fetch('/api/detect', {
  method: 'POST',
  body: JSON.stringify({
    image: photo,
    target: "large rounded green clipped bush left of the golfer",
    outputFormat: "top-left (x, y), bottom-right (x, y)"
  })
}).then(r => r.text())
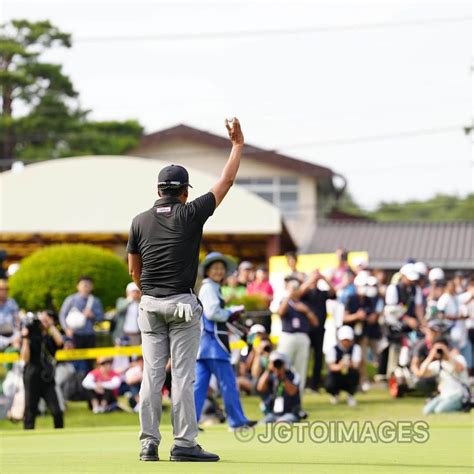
top-left (9, 244), bottom-right (130, 311)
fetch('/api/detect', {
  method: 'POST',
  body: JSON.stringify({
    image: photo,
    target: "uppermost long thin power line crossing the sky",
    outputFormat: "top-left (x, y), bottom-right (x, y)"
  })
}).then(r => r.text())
top-left (75, 16), bottom-right (472, 43)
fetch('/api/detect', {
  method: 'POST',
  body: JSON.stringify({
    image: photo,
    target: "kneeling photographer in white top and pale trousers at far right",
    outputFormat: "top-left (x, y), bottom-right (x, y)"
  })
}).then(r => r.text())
top-left (420, 337), bottom-right (470, 415)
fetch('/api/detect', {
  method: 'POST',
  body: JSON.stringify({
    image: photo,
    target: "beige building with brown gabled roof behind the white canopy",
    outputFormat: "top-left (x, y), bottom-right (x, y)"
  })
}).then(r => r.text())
top-left (130, 124), bottom-right (339, 244)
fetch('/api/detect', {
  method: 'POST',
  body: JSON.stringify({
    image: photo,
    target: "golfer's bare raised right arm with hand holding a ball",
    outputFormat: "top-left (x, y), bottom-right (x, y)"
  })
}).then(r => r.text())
top-left (211, 117), bottom-right (244, 207)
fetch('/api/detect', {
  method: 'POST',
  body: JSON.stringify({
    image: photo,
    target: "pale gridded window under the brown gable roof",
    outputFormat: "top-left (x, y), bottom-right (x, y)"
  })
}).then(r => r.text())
top-left (236, 177), bottom-right (298, 218)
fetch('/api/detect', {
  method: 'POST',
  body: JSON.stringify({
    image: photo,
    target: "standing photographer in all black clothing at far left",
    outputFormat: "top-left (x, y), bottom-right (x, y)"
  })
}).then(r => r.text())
top-left (20, 311), bottom-right (64, 430)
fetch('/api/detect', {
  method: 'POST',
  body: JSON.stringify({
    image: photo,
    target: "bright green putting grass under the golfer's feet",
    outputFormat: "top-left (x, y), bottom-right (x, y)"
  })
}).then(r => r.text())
top-left (0, 390), bottom-right (474, 474)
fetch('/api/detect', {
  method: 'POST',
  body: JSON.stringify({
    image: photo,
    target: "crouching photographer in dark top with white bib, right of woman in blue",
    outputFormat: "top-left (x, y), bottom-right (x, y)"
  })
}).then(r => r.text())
top-left (257, 351), bottom-right (301, 423)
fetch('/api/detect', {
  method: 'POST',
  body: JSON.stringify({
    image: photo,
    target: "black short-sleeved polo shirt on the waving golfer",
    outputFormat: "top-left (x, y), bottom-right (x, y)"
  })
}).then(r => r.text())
top-left (127, 192), bottom-right (216, 297)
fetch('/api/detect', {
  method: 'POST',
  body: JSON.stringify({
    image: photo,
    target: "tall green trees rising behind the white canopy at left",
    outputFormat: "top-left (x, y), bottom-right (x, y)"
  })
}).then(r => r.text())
top-left (0, 20), bottom-right (143, 164)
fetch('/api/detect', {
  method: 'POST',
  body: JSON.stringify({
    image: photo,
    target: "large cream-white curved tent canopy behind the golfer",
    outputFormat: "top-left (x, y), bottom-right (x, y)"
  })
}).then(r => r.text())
top-left (0, 156), bottom-right (282, 235)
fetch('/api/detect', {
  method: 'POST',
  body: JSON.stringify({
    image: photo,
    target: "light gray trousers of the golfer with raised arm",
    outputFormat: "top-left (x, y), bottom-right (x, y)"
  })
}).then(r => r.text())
top-left (138, 293), bottom-right (202, 447)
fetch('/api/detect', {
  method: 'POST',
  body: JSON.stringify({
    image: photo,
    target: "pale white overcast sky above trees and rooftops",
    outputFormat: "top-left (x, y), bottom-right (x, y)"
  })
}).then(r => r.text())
top-left (0, 0), bottom-right (473, 207)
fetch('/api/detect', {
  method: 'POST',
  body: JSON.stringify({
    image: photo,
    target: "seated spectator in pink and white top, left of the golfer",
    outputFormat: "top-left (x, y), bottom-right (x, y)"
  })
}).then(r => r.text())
top-left (82, 357), bottom-right (122, 414)
